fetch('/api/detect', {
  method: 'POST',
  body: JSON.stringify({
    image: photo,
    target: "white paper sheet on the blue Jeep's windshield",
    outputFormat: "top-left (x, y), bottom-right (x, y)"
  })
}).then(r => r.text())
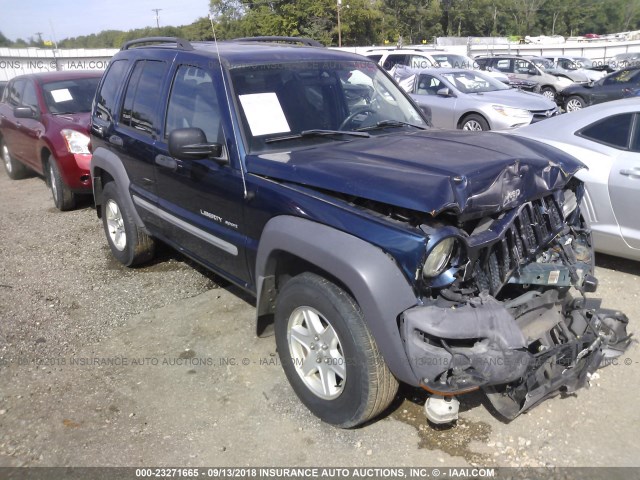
top-left (240, 92), bottom-right (291, 137)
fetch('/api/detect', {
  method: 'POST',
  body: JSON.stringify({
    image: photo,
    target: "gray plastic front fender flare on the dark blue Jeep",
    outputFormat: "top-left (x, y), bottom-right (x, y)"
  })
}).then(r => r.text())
top-left (256, 216), bottom-right (419, 385)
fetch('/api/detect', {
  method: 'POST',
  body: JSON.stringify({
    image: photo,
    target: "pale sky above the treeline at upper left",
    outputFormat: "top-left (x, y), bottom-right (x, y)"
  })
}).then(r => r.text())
top-left (0, 0), bottom-right (209, 40)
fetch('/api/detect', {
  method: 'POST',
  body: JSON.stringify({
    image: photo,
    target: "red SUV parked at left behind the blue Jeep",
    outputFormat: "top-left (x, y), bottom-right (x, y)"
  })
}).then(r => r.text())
top-left (0, 71), bottom-right (102, 210)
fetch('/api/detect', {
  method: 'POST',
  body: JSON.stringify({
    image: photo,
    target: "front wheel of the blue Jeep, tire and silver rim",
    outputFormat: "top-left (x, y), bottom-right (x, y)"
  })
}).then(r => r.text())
top-left (275, 273), bottom-right (398, 428)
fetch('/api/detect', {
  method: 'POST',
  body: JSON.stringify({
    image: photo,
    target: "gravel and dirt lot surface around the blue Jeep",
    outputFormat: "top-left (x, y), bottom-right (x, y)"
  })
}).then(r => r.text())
top-left (0, 174), bottom-right (640, 466)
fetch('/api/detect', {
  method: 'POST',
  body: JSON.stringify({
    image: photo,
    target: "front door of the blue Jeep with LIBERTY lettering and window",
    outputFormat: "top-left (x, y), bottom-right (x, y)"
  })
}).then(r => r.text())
top-left (154, 61), bottom-right (249, 284)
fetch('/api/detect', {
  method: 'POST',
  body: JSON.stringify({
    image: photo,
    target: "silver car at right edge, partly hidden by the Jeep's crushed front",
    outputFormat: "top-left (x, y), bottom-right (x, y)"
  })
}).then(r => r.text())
top-left (510, 98), bottom-right (640, 260)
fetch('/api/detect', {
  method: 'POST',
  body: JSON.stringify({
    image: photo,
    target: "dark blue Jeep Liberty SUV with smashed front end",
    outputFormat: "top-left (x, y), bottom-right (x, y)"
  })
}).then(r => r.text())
top-left (91, 38), bottom-right (628, 427)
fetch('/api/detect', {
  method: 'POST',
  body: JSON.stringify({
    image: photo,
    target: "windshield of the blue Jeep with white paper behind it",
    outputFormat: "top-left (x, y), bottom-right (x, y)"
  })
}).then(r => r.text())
top-left (231, 60), bottom-right (427, 153)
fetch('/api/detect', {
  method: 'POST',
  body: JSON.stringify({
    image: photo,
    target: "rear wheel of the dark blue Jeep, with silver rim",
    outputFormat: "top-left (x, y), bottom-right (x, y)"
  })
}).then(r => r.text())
top-left (101, 182), bottom-right (155, 267)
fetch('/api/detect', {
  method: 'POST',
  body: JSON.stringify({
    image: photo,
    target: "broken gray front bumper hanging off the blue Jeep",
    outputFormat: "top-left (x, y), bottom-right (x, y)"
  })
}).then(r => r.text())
top-left (401, 290), bottom-right (629, 419)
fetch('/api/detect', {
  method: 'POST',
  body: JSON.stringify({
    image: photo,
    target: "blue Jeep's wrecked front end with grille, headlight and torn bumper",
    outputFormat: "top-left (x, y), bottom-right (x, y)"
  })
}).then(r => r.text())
top-left (400, 179), bottom-right (630, 419)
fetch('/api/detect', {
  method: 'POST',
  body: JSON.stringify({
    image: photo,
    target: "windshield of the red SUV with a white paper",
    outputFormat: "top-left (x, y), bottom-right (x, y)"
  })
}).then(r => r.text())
top-left (42, 77), bottom-right (100, 114)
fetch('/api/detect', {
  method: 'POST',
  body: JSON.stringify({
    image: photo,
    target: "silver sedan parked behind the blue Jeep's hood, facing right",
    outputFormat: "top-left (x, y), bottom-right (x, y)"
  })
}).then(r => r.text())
top-left (392, 67), bottom-right (558, 130)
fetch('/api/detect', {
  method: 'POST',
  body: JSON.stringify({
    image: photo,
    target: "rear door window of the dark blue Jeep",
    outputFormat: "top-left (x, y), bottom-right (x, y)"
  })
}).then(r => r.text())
top-left (120, 60), bottom-right (167, 135)
